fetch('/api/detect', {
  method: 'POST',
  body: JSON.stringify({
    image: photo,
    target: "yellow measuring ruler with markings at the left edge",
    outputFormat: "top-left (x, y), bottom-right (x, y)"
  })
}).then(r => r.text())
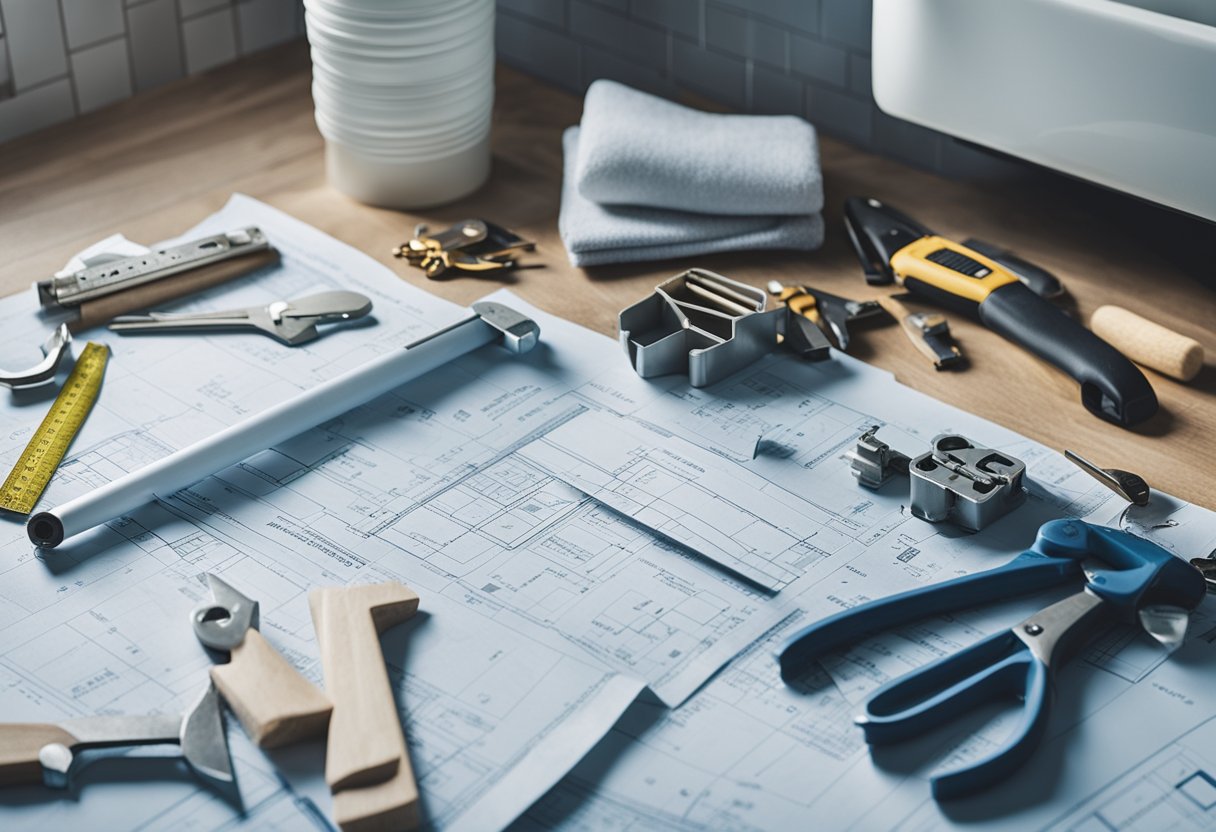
top-left (0, 342), bottom-right (109, 515)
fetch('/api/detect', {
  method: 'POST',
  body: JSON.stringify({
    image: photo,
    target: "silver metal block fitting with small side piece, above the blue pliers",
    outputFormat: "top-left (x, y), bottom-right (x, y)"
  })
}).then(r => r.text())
top-left (845, 426), bottom-right (1026, 532)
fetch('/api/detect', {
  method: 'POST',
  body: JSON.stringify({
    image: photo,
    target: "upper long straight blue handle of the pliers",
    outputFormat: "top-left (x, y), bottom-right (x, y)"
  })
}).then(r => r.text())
top-left (776, 551), bottom-right (1081, 679)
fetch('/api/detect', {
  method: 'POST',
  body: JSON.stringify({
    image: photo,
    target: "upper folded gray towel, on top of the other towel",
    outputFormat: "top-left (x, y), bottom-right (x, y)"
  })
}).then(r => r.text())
top-left (574, 80), bottom-right (823, 215)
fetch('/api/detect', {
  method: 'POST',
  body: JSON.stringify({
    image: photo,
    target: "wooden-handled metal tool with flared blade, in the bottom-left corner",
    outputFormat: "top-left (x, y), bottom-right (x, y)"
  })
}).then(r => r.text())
top-left (0, 684), bottom-right (236, 793)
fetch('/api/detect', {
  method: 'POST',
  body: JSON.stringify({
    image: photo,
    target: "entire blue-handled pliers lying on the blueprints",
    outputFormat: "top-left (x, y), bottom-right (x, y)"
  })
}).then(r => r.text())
top-left (777, 519), bottom-right (1206, 800)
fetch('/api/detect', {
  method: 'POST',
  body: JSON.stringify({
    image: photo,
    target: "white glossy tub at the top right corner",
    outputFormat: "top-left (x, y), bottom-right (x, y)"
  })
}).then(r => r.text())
top-left (873, 0), bottom-right (1216, 221)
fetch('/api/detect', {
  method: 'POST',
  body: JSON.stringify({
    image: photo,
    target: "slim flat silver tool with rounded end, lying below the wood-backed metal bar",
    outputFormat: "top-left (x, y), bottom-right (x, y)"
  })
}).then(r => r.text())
top-left (109, 292), bottom-right (372, 347)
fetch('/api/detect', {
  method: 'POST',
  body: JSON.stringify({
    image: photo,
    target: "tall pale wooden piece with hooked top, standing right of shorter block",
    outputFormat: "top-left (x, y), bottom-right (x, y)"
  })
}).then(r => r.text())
top-left (309, 581), bottom-right (418, 832)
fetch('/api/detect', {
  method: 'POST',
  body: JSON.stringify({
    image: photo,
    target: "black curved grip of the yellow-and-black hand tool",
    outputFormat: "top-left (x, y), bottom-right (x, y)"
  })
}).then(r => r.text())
top-left (979, 283), bottom-right (1158, 426)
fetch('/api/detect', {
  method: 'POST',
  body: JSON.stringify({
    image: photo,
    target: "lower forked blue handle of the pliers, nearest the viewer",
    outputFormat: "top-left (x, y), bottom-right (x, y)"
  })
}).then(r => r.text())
top-left (857, 630), bottom-right (1051, 800)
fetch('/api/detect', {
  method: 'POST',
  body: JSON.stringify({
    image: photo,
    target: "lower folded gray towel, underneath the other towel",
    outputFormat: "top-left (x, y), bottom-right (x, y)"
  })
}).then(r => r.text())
top-left (557, 127), bottom-right (823, 266)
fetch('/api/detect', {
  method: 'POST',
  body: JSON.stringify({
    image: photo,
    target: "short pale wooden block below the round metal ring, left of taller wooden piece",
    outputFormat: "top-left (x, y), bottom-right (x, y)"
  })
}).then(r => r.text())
top-left (212, 630), bottom-right (332, 748)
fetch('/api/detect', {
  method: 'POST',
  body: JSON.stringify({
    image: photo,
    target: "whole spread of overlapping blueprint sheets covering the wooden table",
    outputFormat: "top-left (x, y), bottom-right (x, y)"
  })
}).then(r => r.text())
top-left (0, 197), bottom-right (1216, 830)
